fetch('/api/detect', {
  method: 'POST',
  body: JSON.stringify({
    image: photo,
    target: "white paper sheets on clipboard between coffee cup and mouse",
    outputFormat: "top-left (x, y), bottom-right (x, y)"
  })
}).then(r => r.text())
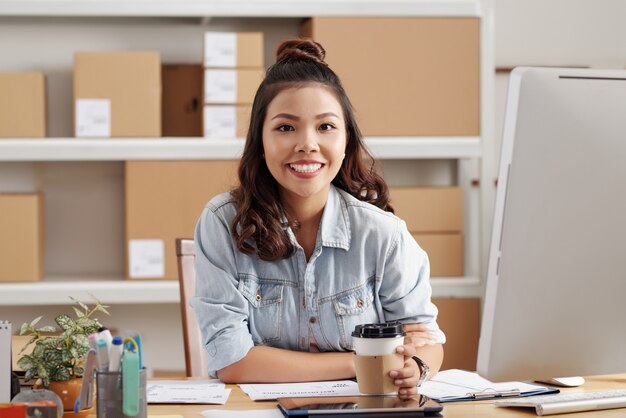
top-left (419, 369), bottom-right (541, 399)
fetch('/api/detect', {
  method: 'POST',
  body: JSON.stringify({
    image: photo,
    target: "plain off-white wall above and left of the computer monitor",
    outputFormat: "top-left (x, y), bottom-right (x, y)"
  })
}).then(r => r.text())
top-left (494, 0), bottom-right (626, 168)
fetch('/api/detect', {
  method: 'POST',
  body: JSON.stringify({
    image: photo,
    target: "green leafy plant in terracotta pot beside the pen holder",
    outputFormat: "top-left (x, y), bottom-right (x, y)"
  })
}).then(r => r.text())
top-left (17, 296), bottom-right (109, 410)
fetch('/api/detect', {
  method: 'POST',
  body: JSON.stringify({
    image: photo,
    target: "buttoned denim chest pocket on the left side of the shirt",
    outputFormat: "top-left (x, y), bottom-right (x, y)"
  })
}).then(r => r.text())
top-left (239, 276), bottom-right (285, 344)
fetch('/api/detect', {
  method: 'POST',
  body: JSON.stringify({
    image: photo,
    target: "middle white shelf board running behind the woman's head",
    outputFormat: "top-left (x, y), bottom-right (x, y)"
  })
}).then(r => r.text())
top-left (0, 137), bottom-right (481, 161)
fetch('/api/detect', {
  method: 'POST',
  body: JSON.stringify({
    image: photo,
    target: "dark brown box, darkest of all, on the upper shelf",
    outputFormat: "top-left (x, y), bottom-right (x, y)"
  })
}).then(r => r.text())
top-left (161, 64), bottom-right (204, 137)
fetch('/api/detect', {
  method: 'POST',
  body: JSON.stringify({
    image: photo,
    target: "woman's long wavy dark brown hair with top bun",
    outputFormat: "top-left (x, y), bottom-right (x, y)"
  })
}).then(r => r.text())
top-left (232, 39), bottom-right (393, 261)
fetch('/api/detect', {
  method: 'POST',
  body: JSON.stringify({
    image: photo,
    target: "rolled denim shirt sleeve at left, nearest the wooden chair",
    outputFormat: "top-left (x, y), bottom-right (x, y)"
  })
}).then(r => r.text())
top-left (191, 204), bottom-right (254, 377)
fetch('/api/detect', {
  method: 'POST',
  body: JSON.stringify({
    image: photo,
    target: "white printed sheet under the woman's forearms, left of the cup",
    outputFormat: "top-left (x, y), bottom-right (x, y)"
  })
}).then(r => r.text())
top-left (239, 380), bottom-right (360, 401)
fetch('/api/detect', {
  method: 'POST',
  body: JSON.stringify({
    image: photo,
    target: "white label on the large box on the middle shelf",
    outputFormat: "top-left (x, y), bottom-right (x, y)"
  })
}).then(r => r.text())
top-left (128, 239), bottom-right (165, 279)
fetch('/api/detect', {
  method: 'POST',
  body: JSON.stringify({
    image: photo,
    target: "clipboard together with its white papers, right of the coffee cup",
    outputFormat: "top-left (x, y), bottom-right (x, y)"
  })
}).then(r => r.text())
top-left (419, 369), bottom-right (559, 402)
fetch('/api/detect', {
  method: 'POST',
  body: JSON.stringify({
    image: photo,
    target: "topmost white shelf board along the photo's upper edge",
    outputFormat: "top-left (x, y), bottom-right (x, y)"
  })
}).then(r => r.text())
top-left (0, 0), bottom-right (483, 17)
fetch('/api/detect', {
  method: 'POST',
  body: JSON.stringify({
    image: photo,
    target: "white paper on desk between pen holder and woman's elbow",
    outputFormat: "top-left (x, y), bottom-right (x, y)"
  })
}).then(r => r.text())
top-left (146, 380), bottom-right (230, 405)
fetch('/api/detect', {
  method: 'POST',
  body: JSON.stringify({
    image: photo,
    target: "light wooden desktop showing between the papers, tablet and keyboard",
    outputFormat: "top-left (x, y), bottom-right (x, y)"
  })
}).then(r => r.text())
top-left (148, 374), bottom-right (626, 418)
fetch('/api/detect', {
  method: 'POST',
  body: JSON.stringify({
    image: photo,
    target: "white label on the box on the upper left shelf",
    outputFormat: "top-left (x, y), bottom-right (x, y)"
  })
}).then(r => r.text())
top-left (75, 99), bottom-right (111, 138)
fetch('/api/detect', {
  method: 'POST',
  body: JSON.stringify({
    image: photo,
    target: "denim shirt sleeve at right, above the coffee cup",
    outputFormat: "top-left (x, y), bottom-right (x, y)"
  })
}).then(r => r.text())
top-left (379, 220), bottom-right (446, 344)
